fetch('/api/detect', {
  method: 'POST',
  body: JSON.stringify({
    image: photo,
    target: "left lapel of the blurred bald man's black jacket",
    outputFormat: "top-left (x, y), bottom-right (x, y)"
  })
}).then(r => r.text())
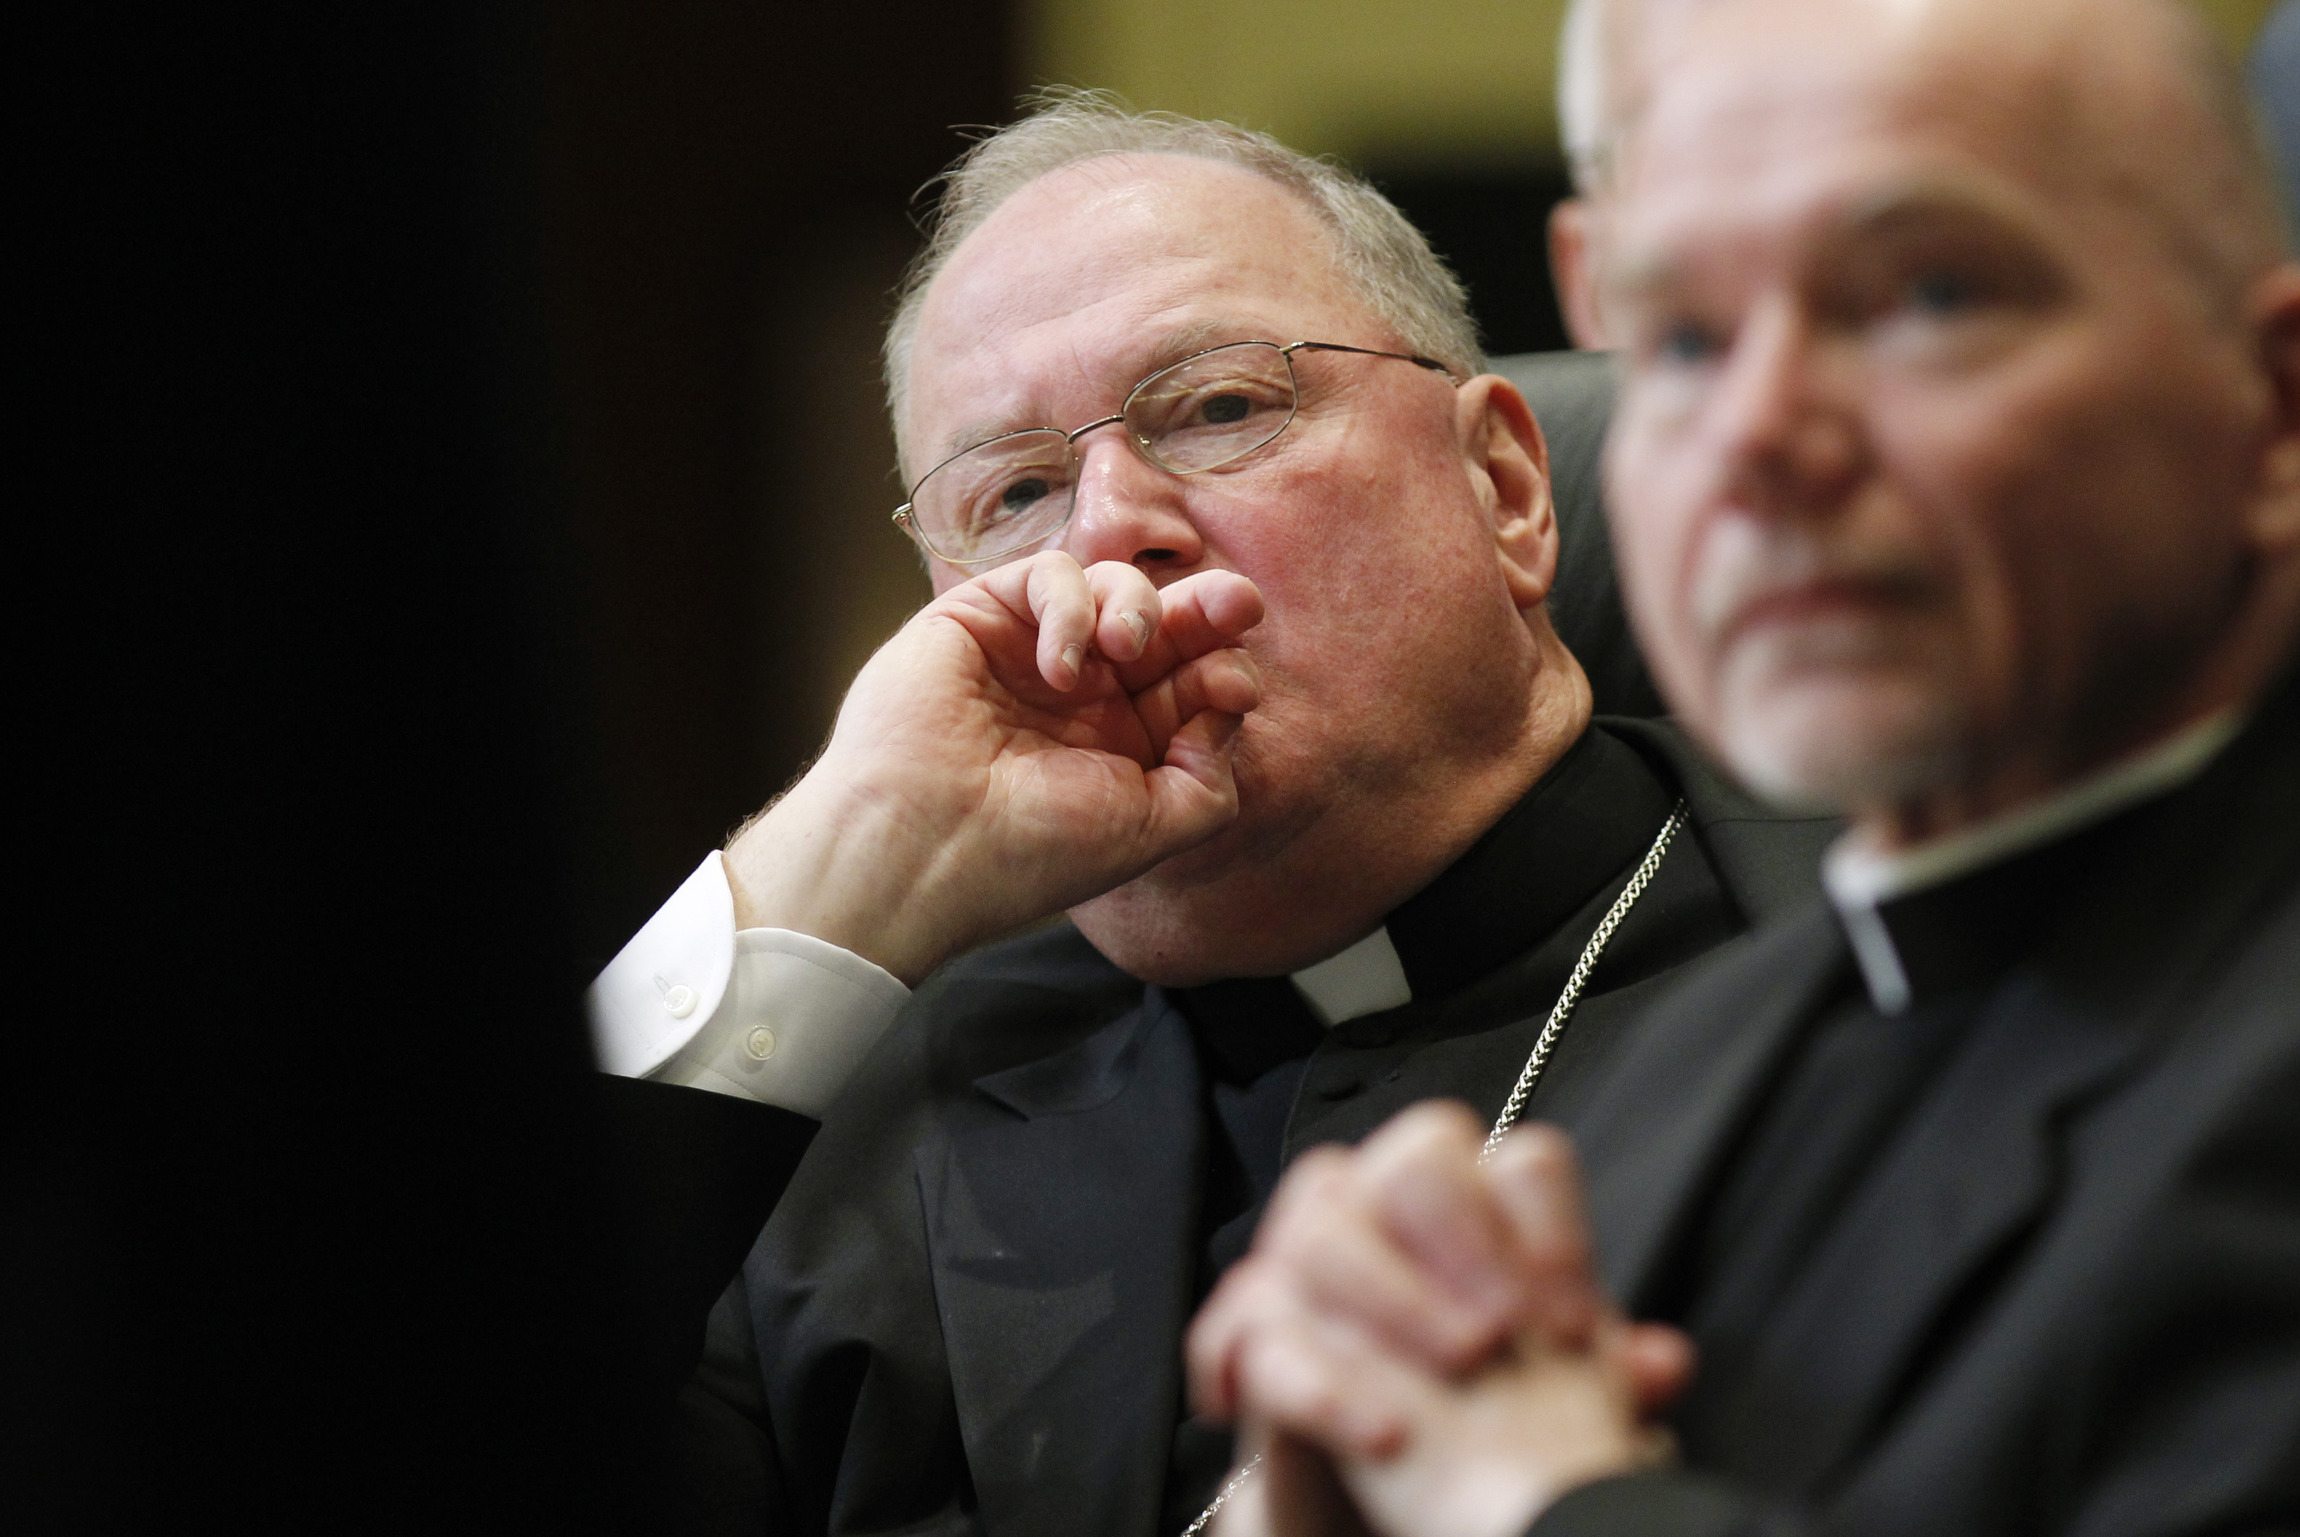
top-left (1566, 902), bottom-right (1849, 1314)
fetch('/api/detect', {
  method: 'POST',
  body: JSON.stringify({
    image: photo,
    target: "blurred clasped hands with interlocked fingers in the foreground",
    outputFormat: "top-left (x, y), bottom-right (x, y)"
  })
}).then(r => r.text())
top-left (1189, 1104), bottom-right (1693, 1537)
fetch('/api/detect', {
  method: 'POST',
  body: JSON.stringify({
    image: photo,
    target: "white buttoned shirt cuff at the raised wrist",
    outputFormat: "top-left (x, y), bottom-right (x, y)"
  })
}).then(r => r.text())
top-left (591, 851), bottom-right (911, 1118)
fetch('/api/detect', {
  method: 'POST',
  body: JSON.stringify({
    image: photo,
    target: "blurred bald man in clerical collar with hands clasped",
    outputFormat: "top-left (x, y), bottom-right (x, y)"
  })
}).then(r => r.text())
top-left (1191, 0), bottom-right (2300, 1537)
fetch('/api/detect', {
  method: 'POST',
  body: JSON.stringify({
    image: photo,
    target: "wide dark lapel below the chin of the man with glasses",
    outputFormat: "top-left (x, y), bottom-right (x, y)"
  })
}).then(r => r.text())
top-left (915, 1003), bottom-right (1203, 1537)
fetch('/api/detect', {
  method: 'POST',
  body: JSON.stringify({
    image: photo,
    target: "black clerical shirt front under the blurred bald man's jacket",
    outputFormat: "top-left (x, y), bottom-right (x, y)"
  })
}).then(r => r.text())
top-left (1661, 808), bottom-right (2180, 1498)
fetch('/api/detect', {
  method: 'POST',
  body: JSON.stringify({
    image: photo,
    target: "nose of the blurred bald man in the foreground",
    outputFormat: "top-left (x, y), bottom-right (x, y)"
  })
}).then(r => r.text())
top-left (1714, 301), bottom-right (1868, 518)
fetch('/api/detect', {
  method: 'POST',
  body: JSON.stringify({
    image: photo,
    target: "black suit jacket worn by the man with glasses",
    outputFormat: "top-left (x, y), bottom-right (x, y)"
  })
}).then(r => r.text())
top-left (690, 720), bottom-right (1833, 1537)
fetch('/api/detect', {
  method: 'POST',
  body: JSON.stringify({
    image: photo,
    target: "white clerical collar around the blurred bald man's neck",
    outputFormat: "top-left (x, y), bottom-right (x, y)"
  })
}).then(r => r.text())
top-left (1822, 709), bottom-right (2245, 1015)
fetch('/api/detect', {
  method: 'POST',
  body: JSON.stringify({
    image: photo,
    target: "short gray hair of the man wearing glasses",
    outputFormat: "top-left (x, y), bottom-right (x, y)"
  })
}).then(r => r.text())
top-left (886, 87), bottom-right (1486, 462)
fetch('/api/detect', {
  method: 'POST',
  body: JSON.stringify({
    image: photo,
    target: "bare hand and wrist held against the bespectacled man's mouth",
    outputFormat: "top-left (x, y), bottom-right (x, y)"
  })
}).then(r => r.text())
top-left (727, 552), bottom-right (1263, 982)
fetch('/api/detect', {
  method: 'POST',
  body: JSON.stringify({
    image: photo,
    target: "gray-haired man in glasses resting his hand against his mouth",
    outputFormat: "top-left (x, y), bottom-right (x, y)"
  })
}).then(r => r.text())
top-left (593, 99), bottom-right (1829, 1537)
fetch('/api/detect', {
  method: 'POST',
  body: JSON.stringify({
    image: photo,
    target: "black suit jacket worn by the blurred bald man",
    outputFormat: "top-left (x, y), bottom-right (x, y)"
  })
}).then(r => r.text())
top-left (1534, 683), bottom-right (2300, 1537)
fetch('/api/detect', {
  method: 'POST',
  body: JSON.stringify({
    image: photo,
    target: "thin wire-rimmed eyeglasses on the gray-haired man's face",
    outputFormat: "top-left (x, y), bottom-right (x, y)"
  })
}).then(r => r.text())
top-left (895, 341), bottom-right (1454, 566)
